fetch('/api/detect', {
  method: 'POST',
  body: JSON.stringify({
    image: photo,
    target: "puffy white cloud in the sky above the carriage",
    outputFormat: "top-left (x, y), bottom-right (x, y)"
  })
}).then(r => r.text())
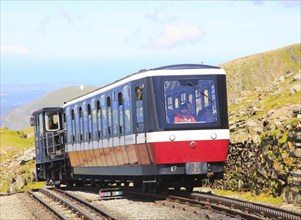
top-left (151, 22), bottom-right (203, 48)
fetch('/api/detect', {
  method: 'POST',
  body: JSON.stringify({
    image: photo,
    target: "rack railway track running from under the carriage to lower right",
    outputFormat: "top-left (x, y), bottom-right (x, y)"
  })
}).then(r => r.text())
top-left (122, 191), bottom-right (301, 220)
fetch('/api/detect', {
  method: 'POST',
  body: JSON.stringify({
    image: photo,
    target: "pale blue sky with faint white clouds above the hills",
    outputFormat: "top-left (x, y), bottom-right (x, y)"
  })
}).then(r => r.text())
top-left (1, 0), bottom-right (301, 86)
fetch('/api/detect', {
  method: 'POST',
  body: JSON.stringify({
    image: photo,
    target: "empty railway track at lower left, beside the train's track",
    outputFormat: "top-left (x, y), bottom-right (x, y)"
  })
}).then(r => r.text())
top-left (29, 188), bottom-right (114, 220)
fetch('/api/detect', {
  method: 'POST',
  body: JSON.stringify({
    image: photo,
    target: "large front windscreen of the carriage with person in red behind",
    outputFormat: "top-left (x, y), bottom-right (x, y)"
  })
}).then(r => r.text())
top-left (164, 79), bottom-right (218, 124)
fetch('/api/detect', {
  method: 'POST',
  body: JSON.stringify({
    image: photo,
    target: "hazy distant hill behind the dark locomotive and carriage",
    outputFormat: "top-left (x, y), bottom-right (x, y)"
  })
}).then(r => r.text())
top-left (2, 86), bottom-right (97, 130)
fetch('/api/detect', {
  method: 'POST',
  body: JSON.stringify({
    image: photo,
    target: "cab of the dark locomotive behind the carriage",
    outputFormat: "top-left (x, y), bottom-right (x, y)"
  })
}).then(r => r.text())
top-left (30, 107), bottom-right (65, 163)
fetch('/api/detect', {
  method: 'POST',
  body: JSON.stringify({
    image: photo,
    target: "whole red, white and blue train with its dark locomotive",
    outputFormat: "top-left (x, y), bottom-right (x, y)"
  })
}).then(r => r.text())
top-left (31, 64), bottom-right (229, 191)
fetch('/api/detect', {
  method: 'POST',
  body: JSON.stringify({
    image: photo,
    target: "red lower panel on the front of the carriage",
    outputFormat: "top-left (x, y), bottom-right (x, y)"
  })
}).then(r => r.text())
top-left (149, 140), bottom-right (229, 164)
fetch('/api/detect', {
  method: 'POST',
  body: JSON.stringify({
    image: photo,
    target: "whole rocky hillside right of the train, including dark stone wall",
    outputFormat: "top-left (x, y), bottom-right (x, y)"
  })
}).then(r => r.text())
top-left (209, 44), bottom-right (301, 206)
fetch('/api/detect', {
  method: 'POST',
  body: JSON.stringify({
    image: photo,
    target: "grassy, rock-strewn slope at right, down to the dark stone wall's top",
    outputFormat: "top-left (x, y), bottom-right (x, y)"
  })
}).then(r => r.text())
top-left (221, 44), bottom-right (301, 142)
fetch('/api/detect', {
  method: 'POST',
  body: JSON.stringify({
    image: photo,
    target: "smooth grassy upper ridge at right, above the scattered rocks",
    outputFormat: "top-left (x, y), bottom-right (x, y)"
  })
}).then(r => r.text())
top-left (220, 44), bottom-right (301, 104)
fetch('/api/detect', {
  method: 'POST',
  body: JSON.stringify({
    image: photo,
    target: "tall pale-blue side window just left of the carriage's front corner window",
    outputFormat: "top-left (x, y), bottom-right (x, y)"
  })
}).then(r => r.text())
top-left (123, 86), bottom-right (132, 134)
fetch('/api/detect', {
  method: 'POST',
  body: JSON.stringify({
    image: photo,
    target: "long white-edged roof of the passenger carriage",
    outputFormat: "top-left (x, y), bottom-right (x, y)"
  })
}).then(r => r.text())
top-left (64, 64), bottom-right (225, 107)
